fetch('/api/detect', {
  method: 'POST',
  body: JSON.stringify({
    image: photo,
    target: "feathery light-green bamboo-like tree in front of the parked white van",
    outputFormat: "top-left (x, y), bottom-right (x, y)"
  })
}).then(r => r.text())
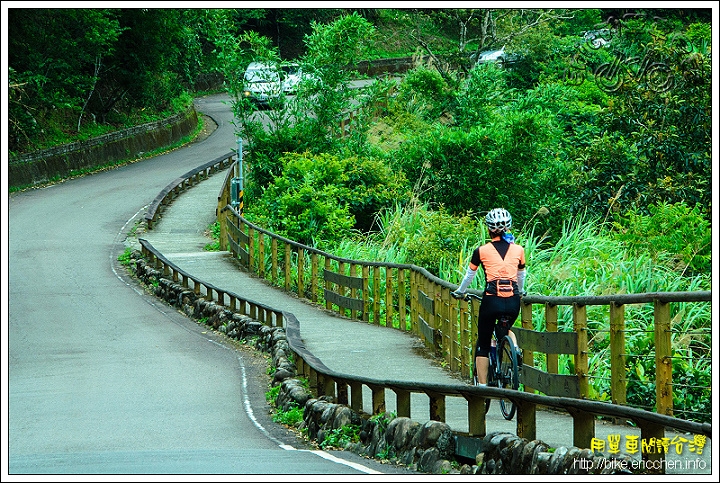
top-left (226, 14), bottom-right (374, 197)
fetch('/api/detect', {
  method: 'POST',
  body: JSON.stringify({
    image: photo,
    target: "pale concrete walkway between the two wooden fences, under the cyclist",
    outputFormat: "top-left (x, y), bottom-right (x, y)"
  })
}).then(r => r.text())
top-left (127, 167), bottom-right (710, 473)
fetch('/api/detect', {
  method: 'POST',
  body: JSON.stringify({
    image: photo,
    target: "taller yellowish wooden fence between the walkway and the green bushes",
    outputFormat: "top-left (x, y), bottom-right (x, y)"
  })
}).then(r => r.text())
top-left (217, 161), bottom-right (711, 422)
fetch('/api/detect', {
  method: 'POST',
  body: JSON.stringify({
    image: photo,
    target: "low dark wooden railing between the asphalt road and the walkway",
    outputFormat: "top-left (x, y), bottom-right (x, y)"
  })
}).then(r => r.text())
top-left (134, 239), bottom-right (712, 464)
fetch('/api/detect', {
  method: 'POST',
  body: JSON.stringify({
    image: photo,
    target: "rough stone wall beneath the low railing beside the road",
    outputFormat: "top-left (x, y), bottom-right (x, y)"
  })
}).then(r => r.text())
top-left (130, 250), bottom-right (632, 475)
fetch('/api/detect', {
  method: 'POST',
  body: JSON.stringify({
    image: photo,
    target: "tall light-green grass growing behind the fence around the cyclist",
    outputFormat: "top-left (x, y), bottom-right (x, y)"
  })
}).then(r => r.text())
top-left (332, 205), bottom-right (711, 421)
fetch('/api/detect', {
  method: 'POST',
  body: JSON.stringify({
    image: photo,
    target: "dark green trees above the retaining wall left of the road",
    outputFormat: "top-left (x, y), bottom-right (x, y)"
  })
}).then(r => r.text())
top-left (7, 8), bottom-right (343, 153)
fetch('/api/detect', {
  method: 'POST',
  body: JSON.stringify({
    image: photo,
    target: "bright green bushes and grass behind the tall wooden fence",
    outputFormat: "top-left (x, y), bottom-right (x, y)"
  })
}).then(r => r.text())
top-left (218, 8), bottom-right (711, 420)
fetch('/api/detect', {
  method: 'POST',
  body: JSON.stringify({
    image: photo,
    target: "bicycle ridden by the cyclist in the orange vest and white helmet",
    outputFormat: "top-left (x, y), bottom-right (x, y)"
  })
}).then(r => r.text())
top-left (462, 293), bottom-right (520, 421)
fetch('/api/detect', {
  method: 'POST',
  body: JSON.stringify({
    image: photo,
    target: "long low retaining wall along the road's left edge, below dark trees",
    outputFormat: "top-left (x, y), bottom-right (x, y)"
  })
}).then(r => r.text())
top-left (8, 107), bottom-right (198, 188)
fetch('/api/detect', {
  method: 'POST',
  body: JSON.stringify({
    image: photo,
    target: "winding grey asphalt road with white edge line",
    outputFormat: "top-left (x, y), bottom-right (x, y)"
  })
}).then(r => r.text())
top-left (2, 95), bottom-right (416, 481)
